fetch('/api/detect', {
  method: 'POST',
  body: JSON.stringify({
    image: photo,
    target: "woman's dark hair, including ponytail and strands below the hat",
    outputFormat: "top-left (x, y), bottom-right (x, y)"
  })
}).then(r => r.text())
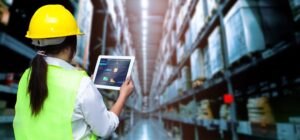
top-left (28, 36), bottom-right (77, 116)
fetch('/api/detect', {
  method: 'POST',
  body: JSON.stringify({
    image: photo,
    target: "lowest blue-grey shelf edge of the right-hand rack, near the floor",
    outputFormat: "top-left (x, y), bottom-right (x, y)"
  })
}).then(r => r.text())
top-left (161, 115), bottom-right (296, 139)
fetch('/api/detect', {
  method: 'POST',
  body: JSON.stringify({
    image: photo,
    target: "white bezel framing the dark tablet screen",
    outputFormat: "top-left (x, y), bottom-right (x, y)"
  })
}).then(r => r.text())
top-left (93, 55), bottom-right (135, 90)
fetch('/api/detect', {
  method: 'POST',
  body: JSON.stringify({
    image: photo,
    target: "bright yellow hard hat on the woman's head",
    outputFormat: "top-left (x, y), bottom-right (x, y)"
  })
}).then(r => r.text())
top-left (26, 5), bottom-right (83, 39)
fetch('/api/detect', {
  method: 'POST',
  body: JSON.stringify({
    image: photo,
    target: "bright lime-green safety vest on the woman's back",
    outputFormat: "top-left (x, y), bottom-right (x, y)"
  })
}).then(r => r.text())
top-left (13, 65), bottom-right (96, 140)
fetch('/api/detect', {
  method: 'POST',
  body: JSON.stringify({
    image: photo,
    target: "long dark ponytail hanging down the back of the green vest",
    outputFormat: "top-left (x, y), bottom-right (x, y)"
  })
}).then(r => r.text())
top-left (28, 54), bottom-right (48, 116)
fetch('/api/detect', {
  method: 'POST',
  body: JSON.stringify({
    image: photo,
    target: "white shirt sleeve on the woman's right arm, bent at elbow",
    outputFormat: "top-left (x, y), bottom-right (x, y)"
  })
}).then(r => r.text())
top-left (78, 77), bottom-right (119, 137)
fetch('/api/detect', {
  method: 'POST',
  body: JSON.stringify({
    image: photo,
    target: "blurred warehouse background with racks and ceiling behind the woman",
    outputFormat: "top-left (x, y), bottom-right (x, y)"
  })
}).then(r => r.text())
top-left (0, 0), bottom-right (300, 140)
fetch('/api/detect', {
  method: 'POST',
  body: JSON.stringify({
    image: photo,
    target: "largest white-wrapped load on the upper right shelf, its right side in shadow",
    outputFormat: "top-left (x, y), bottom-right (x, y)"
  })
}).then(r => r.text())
top-left (225, 0), bottom-right (291, 64)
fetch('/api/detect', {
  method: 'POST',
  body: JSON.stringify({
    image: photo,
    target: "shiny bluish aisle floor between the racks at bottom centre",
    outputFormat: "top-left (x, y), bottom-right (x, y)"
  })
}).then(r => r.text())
top-left (121, 119), bottom-right (171, 140)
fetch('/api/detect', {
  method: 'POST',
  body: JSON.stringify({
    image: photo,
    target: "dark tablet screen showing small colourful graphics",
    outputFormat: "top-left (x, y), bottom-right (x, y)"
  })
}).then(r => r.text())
top-left (94, 58), bottom-right (131, 87)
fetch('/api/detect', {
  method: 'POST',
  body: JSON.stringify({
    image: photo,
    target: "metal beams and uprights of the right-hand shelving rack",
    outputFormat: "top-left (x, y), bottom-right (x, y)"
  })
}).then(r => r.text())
top-left (151, 0), bottom-right (300, 140)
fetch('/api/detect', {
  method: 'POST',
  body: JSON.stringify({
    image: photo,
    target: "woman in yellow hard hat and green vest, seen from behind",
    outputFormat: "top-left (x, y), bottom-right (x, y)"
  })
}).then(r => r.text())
top-left (13, 5), bottom-right (133, 140)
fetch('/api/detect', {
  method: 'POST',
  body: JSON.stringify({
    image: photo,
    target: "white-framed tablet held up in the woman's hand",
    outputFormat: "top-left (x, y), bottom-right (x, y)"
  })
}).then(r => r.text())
top-left (93, 55), bottom-right (135, 90)
